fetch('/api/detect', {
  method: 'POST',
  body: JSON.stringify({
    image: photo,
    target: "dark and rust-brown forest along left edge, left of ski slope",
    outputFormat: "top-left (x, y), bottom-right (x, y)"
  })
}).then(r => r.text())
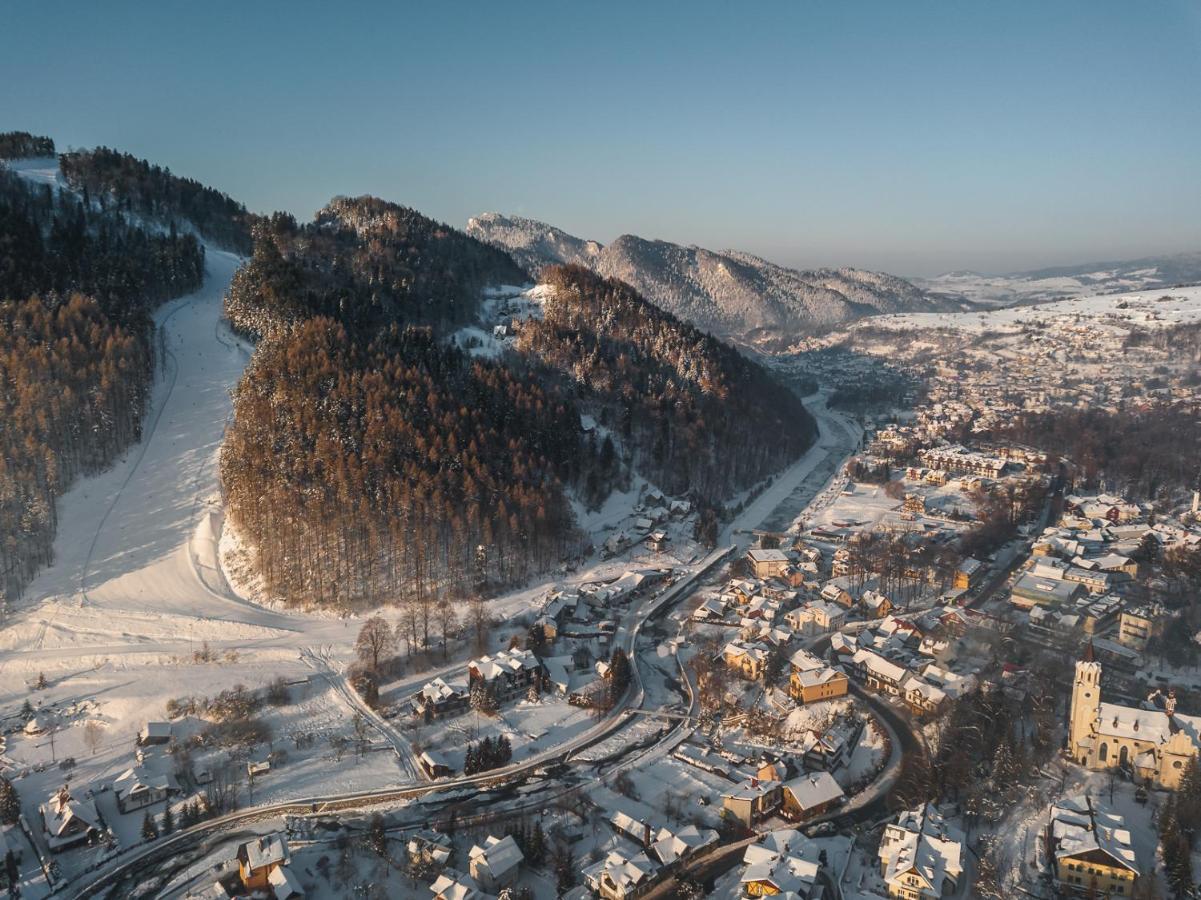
top-left (0, 133), bottom-right (204, 597)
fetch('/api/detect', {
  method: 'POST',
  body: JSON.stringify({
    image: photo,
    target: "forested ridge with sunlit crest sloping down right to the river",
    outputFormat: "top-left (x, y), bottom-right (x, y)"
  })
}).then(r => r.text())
top-left (518, 266), bottom-right (817, 501)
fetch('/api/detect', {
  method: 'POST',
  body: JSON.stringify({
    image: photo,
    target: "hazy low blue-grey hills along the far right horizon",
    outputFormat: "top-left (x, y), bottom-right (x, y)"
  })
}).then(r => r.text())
top-left (914, 252), bottom-right (1201, 306)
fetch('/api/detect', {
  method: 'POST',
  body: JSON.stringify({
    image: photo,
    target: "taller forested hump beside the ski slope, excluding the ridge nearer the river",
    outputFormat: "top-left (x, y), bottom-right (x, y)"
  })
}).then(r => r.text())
top-left (221, 197), bottom-right (587, 607)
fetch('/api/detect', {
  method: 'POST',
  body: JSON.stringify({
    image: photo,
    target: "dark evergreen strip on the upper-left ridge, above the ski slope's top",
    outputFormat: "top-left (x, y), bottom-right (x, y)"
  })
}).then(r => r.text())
top-left (59, 147), bottom-right (255, 255)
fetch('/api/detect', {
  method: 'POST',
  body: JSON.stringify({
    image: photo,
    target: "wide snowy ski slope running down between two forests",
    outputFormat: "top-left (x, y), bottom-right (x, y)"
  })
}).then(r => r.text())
top-left (0, 248), bottom-right (341, 673)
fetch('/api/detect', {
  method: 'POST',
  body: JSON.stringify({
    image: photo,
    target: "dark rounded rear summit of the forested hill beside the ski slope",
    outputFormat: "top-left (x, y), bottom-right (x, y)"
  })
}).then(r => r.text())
top-left (226, 197), bottom-right (528, 338)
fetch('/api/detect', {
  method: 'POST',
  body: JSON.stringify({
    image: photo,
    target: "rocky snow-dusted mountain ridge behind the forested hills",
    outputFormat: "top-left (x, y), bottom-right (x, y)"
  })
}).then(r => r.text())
top-left (467, 213), bottom-right (941, 344)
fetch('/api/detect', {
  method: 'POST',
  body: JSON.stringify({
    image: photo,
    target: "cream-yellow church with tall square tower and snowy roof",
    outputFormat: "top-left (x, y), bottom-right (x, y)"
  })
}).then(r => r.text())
top-left (1068, 644), bottom-right (1201, 791)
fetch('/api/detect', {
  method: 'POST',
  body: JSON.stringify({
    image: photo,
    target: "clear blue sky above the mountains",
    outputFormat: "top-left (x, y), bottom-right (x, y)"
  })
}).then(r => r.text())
top-left (0, 0), bottom-right (1201, 274)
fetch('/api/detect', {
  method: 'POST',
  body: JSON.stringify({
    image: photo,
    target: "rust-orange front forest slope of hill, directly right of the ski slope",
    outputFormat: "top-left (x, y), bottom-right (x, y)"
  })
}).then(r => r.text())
top-left (221, 317), bottom-right (580, 607)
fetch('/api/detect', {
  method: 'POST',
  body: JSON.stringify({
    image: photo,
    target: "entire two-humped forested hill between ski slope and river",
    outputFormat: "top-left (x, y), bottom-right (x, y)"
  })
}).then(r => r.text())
top-left (221, 197), bottom-right (814, 607)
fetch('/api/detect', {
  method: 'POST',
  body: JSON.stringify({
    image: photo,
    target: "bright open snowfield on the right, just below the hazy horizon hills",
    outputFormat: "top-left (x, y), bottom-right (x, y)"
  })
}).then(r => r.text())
top-left (852, 286), bottom-right (1201, 333)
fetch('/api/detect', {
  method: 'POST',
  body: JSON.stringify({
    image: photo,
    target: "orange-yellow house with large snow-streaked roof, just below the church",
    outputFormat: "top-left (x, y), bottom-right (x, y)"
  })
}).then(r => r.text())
top-left (1045, 794), bottom-right (1139, 898)
